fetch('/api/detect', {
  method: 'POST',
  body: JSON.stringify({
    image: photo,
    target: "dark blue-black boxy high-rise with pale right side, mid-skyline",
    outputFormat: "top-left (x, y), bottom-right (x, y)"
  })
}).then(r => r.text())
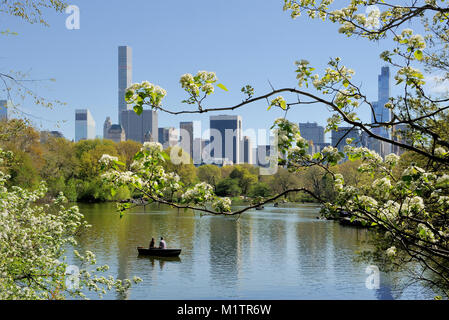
top-left (209, 115), bottom-right (243, 164)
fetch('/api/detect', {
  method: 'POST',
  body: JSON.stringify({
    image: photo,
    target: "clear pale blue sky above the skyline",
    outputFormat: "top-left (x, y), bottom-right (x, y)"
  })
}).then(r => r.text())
top-left (0, 0), bottom-right (400, 143)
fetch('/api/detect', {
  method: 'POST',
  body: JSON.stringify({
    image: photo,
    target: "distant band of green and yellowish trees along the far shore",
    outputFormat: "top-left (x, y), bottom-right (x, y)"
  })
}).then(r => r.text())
top-left (0, 119), bottom-right (420, 202)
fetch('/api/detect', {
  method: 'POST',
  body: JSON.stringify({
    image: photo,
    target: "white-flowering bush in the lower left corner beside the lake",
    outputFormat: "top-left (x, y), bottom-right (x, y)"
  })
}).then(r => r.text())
top-left (0, 149), bottom-right (141, 300)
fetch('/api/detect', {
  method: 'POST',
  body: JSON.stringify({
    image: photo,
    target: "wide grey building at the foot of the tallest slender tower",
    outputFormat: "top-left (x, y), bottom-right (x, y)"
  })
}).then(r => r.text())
top-left (122, 110), bottom-right (159, 143)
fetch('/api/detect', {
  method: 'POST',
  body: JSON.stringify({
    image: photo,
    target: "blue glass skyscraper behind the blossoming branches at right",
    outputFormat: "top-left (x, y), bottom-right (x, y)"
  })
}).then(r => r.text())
top-left (370, 67), bottom-right (391, 156)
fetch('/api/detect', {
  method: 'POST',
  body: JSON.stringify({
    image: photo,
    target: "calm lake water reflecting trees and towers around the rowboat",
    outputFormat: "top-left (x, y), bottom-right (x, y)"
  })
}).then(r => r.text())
top-left (75, 204), bottom-right (432, 299)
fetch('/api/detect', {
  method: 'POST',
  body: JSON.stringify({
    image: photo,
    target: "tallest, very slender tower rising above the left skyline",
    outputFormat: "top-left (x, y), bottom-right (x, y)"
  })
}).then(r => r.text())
top-left (118, 46), bottom-right (133, 125)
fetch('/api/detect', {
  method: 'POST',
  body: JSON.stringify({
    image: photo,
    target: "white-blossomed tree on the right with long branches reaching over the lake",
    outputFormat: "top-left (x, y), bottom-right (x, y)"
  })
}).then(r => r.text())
top-left (102, 0), bottom-right (449, 296)
